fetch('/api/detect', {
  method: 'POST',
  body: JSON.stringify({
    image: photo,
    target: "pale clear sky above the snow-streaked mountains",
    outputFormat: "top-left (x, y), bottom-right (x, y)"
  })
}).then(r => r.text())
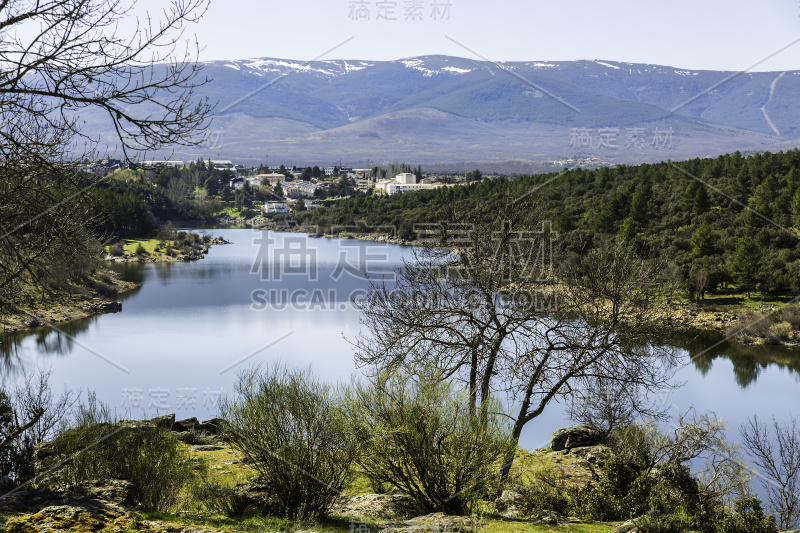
top-left (147, 0), bottom-right (800, 71)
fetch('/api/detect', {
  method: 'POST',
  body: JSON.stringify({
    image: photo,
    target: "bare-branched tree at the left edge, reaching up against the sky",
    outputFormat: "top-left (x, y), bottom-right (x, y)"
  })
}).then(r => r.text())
top-left (0, 0), bottom-right (211, 306)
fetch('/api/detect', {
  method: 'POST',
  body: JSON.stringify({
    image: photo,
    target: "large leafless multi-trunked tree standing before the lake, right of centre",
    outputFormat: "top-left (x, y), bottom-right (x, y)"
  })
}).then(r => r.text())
top-left (355, 197), bottom-right (677, 480)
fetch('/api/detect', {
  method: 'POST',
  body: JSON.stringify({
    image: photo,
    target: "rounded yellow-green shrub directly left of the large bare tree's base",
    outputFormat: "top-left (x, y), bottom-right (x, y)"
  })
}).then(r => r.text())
top-left (348, 372), bottom-right (513, 513)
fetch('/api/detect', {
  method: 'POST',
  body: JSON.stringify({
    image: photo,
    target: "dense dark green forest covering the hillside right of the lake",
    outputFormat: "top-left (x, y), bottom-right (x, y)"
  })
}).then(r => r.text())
top-left (282, 150), bottom-right (800, 298)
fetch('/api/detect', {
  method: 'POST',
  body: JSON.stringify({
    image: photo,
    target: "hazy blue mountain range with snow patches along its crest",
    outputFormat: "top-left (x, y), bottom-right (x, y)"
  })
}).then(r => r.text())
top-left (123, 55), bottom-right (800, 171)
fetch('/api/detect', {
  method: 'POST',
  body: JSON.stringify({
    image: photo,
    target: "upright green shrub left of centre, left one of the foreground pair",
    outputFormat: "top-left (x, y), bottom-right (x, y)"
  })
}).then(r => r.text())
top-left (221, 364), bottom-right (358, 519)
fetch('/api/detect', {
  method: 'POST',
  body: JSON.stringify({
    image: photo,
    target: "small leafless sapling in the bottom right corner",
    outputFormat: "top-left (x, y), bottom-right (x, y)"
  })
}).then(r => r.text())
top-left (740, 416), bottom-right (800, 529)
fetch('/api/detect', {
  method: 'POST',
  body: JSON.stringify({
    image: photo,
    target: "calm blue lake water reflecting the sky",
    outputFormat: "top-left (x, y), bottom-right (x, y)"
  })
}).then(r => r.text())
top-left (0, 229), bottom-right (800, 448)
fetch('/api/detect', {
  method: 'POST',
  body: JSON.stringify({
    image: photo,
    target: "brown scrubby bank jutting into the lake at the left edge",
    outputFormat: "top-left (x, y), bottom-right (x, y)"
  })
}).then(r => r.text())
top-left (0, 269), bottom-right (139, 333)
